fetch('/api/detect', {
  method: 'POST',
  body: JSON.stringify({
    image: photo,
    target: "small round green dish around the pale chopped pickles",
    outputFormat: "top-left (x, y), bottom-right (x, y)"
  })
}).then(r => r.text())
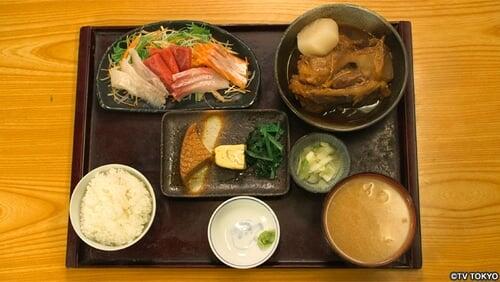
top-left (288, 133), bottom-right (351, 193)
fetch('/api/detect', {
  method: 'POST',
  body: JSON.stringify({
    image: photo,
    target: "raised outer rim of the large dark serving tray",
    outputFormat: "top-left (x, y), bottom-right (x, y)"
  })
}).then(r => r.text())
top-left (66, 20), bottom-right (422, 269)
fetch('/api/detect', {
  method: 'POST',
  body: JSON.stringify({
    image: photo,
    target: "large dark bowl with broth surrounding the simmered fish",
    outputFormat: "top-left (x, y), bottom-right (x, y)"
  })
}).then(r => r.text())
top-left (274, 4), bottom-right (408, 131)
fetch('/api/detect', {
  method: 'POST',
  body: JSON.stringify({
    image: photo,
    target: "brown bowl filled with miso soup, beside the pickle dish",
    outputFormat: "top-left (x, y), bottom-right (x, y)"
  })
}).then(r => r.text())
top-left (322, 173), bottom-right (416, 267)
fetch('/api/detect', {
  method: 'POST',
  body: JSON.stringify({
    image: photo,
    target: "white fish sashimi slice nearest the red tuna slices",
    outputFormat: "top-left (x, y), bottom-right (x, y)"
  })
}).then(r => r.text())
top-left (120, 60), bottom-right (166, 108)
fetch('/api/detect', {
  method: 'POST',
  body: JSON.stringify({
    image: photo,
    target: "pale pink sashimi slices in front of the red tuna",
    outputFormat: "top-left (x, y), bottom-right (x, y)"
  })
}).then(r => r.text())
top-left (172, 68), bottom-right (229, 100)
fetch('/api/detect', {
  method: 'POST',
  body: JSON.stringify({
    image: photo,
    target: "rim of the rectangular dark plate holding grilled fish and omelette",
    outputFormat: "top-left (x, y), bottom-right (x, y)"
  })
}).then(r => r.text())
top-left (160, 109), bottom-right (290, 199)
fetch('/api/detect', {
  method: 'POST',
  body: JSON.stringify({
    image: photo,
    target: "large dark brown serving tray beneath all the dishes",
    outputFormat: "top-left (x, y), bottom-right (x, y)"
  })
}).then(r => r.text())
top-left (66, 22), bottom-right (422, 268)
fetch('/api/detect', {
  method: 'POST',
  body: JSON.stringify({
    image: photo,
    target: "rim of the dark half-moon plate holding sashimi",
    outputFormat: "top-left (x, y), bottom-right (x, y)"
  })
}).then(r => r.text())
top-left (95, 20), bottom-right (261, 113)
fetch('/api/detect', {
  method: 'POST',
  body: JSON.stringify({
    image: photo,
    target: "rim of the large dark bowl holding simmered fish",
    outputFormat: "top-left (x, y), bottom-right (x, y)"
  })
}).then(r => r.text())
top-left (274, 4), bottom-right (409, 132)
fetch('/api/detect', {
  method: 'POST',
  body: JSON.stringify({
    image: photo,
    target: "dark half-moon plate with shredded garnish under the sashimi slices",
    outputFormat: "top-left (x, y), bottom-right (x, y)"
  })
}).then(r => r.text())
top-left (96, 20), bottom-right (260, 113)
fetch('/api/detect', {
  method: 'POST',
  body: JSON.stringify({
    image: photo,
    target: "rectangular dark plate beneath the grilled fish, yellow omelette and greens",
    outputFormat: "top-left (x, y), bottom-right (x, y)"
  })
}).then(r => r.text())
top-left (161, 110), bottom-right (290, 197)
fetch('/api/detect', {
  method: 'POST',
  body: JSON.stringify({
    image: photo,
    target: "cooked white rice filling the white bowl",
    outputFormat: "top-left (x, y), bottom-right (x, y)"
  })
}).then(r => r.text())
top-left (80, 168), bottom-right (152, 246)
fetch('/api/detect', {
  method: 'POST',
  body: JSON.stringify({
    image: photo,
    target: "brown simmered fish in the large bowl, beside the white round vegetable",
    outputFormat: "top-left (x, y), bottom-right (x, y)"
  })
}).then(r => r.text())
top-left (289, 21), bottom-right (393, 113)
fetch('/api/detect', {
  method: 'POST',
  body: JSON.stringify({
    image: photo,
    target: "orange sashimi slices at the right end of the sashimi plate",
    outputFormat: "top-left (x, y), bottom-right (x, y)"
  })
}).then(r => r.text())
top-left (193, 43), bottom-right (248, 89)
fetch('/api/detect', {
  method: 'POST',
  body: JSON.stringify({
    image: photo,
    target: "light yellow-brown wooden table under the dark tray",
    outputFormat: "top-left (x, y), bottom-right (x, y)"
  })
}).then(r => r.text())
top-left (0, 0), bottom-right (500, 281)
